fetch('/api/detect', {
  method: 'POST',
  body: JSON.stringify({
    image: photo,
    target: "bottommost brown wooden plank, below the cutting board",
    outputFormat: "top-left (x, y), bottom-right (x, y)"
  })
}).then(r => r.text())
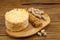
top-left (0, 33), bottom-right (60, 40)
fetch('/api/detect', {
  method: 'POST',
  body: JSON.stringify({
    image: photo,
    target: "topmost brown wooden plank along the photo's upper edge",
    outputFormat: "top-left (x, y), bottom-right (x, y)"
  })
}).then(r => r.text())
top-left (0, 0), bottom-right (60, 4)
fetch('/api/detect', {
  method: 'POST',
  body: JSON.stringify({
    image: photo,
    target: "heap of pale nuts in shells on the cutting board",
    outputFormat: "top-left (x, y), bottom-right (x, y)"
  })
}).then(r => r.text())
top-left (28, 8), bottom-right (46, 20)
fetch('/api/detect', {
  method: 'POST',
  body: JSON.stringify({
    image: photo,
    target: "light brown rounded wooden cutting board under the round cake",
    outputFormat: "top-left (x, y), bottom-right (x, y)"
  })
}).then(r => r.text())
top-left (6, 13), bottom-right (50, 38)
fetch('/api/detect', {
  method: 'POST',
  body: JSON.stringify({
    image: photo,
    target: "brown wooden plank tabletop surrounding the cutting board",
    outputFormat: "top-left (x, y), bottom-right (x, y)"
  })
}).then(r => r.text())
top-left (0, 0), bottom-right (60, 40)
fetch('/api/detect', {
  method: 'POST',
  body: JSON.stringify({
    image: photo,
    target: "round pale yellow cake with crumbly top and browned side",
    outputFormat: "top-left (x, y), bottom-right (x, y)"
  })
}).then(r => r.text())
top-left (5, 8), bottom-right (29, 31)
